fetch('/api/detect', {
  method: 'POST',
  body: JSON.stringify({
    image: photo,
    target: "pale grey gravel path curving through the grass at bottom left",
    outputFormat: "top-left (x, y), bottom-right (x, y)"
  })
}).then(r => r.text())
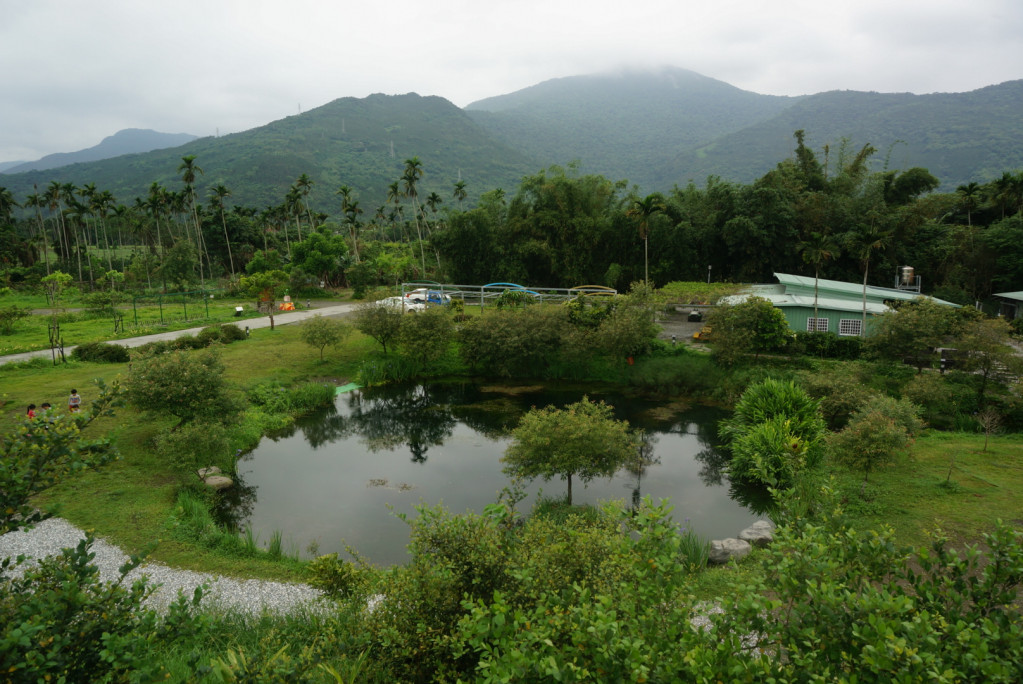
top-left (0, 517), bottom-right (322, 615)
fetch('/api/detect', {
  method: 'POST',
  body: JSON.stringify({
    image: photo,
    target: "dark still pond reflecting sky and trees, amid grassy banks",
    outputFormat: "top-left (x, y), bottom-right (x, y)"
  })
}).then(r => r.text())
top-left (227, 382), bottom-right (757, 565)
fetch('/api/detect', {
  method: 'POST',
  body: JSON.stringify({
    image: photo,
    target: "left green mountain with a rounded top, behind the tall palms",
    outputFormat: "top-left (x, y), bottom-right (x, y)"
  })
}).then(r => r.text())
top-left (3, 93), bottom-right (538, 210)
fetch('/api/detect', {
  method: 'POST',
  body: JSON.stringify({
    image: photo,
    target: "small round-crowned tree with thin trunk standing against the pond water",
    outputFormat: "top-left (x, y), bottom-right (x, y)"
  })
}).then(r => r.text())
top-left (501, 397), bottom-right (639, 505)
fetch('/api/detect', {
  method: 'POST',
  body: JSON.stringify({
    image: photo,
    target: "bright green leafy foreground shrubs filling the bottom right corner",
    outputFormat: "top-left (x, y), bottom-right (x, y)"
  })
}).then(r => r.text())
top-left (451, 491), bottom-right (1023, 682)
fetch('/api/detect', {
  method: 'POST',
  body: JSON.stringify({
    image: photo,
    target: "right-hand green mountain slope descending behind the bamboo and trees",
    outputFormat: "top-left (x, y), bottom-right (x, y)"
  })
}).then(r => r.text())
top-left (660, 81), bottom-right (1023, 190)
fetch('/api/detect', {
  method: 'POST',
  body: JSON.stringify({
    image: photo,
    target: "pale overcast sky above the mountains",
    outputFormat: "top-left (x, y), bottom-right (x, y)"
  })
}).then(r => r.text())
top-left (0, 0), bottom-right (1023, 162)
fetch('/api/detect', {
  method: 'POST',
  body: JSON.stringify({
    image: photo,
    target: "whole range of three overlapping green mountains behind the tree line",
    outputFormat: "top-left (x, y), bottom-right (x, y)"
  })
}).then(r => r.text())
top-left (3, 69), bottom-right (1023, 214)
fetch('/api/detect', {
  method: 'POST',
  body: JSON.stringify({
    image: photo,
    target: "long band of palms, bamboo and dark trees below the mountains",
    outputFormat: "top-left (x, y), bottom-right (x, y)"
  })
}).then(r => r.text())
top-left (0, 131), bottom-right (1023, 304)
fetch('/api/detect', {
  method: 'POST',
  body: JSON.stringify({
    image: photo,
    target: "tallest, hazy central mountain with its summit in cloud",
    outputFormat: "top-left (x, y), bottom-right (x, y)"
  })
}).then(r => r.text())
top-left (465, 69), bottom-right (799, 187)
